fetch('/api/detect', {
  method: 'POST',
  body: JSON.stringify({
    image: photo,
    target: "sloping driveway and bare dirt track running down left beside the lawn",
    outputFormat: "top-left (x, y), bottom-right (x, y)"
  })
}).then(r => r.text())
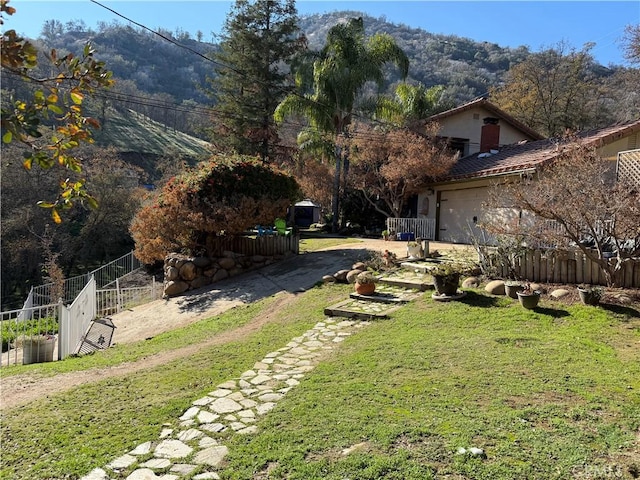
top-left (0, 239), bottom-right (465, 410)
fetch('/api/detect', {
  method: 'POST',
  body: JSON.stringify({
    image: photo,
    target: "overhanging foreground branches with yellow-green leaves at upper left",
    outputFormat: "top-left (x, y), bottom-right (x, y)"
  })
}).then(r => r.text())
top-left (0, 0), bottom-right (113, 223)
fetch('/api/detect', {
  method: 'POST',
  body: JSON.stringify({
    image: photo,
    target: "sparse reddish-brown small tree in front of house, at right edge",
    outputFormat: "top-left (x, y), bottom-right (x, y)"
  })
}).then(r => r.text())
top-left (483, 139), bottom-right (640, 285)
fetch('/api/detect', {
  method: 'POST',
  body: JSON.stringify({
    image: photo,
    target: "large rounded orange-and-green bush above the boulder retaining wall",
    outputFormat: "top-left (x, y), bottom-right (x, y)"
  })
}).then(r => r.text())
top-left (130, 156), bottom-right (300, 264)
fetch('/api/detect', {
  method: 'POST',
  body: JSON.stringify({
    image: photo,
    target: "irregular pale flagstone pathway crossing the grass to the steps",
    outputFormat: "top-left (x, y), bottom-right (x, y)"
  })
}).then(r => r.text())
top-left (81, 317), bottom-right (368, 480)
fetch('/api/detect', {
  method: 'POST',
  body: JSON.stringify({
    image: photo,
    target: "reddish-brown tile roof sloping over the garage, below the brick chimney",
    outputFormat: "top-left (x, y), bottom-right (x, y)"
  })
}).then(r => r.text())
top-left (443, 119), bottom-right (640, 181)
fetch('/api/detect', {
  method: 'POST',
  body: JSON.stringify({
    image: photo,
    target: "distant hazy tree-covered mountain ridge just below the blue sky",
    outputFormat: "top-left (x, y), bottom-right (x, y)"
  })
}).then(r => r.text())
top-left (26, 11), bottom-right (540, 112)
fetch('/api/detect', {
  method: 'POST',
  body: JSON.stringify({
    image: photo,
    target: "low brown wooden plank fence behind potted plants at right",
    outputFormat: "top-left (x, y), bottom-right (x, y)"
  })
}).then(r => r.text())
top-left (496, 249), bottom-right (640, 288)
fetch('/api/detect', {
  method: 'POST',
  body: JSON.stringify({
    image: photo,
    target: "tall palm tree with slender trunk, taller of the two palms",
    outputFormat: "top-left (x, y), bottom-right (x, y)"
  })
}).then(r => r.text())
top-left (274, 18), bottom-right (409, 231)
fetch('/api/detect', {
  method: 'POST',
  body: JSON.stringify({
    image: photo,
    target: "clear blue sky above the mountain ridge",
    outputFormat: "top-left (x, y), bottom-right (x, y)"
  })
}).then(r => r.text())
top-left (4, 0), bottom-right (640, 65)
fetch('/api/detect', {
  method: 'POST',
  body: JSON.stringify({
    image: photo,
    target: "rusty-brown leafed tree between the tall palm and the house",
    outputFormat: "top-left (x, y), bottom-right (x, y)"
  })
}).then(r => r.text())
top-left (348, 124), bottom-right (457, 217)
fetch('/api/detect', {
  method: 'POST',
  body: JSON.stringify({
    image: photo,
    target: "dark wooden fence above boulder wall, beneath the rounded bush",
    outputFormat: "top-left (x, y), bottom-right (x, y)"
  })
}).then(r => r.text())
top-left (207, 233), bottom-right (300, 257)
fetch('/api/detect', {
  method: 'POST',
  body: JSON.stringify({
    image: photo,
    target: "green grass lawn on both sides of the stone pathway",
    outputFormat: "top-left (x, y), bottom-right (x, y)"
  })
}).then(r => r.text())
top-left (0, 285), bottom-right (640, 480)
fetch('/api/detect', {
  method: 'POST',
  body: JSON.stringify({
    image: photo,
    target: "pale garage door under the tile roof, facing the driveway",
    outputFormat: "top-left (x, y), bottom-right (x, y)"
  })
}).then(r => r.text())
top-left (438, 187), bottom-right (487, 244)
